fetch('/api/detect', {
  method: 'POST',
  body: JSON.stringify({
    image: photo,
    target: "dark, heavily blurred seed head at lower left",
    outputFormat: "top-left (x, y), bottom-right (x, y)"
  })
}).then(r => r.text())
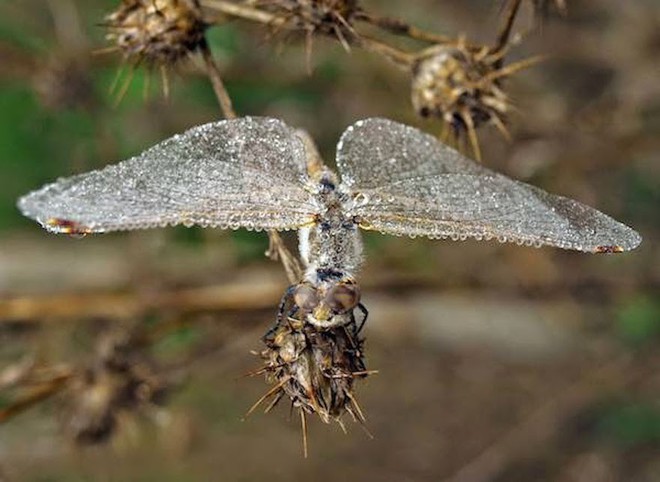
top-left (65, 332), bottom-right (167, 445)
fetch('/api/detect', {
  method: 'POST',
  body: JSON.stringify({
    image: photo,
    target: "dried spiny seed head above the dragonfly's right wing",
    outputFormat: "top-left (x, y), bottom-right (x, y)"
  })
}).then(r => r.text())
top-left (412, 40), bottom-right (538, 159)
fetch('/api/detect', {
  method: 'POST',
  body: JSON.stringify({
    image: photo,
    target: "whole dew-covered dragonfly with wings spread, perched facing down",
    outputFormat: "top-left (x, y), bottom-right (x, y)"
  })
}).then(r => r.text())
top-left (18, 117), bottom-right (641, 329)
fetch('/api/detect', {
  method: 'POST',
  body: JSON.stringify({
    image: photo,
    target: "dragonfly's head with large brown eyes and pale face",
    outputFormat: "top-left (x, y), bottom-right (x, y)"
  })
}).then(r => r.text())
top-left (293, 279), bottom-right (360, 327)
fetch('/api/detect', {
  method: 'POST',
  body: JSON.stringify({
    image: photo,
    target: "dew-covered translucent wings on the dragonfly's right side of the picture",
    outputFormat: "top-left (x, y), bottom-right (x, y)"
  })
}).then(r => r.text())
top-left (337, 119), bottom-right (641, 252)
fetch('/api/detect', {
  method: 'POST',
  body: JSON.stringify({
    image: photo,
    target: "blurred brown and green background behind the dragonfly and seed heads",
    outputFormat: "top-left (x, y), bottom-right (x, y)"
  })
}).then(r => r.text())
top-left (0, 0), bottom-right (660, 482)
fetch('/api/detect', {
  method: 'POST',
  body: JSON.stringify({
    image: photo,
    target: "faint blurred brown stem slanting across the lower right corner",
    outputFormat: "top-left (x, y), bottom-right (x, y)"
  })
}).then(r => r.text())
top-left (446, 354), bottom-right (634, 482)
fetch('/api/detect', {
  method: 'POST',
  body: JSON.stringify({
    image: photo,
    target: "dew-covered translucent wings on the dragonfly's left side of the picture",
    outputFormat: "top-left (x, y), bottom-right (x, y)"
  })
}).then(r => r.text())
top-left (18, 117), bottom-right (315, 233)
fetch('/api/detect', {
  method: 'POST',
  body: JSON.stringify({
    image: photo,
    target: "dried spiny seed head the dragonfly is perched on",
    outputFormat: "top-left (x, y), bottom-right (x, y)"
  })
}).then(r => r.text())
top-left (261, 318), bottom-right (366, 425)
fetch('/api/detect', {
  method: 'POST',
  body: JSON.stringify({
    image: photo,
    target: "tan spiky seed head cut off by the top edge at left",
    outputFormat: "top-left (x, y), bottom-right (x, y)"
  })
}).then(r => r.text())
top-left (106, 0), bottom-right (206, 66)
